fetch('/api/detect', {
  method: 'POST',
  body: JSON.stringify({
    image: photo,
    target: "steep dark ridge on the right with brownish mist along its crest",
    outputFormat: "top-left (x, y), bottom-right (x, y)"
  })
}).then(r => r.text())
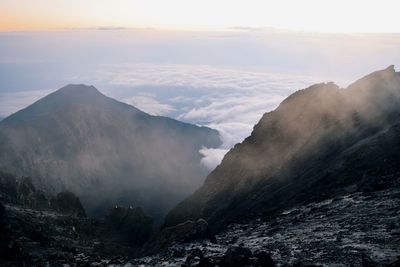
top-left (165, 66), bottom-right (400, 230)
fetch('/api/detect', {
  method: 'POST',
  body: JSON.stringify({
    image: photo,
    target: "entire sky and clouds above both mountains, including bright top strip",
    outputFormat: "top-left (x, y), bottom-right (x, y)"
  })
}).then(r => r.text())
top-left (0, 0), bottom-right (400, 169)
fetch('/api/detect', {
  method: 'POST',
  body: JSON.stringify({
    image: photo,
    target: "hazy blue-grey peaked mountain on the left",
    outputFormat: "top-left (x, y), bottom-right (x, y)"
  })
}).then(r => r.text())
top-left (0, 85), bottom-right (221, 219)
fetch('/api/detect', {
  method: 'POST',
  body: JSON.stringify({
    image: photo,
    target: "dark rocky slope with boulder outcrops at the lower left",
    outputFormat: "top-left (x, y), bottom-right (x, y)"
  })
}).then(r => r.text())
top-left (0, 172), bottom-right (153, 266)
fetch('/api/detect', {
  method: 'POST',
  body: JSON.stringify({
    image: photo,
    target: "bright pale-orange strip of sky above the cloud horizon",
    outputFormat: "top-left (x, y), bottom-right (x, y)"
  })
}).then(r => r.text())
top-left (0, 0), bottom-right (400, 33)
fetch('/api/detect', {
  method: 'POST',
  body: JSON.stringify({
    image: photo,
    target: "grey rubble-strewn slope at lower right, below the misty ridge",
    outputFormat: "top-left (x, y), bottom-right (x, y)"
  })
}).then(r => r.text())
top-left (131, 189), bottom-right (400, 266)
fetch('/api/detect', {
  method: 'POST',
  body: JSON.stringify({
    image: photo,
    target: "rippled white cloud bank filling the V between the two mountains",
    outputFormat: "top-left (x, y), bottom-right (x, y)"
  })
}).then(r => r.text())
top-left (90, 64), bottom-right (321, 169)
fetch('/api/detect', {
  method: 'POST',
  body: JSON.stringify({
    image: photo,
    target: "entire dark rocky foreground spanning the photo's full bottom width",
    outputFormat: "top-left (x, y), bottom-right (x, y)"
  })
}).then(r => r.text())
top-left (0, 175), bottom-right (400, 267)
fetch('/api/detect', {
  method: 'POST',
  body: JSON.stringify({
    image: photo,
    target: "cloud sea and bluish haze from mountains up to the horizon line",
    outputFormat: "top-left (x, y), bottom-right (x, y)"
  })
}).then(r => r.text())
top-left (0, 28), bottom-right (400, 169)
